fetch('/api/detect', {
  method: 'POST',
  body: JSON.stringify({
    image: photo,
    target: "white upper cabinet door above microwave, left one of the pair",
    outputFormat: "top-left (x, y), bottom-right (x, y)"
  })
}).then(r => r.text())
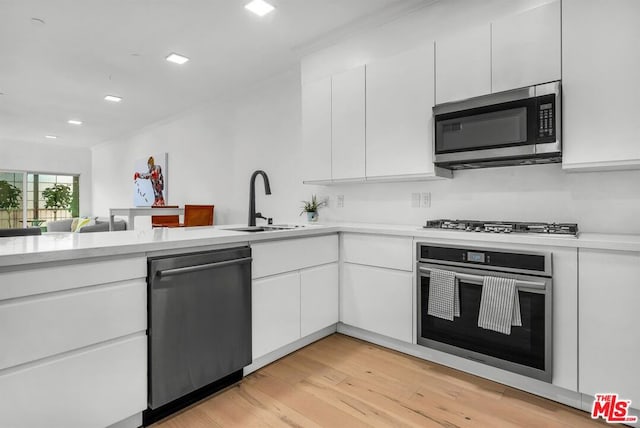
top-left (436, 24), bottom-right (491, 104)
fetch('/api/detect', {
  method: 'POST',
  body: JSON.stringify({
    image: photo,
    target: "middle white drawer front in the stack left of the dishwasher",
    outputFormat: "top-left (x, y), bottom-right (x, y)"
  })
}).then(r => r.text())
top-left (0, 280), bottom-right (147, 369)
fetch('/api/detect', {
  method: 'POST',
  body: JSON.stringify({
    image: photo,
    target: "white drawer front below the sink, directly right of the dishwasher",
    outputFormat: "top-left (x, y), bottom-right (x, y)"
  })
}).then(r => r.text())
top-left (251, 234), bottom-right (338, 278)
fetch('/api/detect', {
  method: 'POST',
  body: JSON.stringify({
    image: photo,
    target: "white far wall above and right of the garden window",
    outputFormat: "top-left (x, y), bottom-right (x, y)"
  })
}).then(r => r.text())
top-left (0, 141), bottom-right (93, 215)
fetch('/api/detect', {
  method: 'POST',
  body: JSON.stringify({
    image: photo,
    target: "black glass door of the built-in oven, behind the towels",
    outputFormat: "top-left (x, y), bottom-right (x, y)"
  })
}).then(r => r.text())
top-left (418, 275), bottom-right (549, 371)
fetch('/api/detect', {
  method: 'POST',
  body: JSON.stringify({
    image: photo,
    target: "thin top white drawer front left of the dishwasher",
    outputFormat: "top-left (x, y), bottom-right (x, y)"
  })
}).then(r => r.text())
top-left (0, 257), bottom-right (147, 300)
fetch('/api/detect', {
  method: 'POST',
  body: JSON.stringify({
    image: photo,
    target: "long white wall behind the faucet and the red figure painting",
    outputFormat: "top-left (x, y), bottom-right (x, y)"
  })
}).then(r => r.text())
top-left (93, 69), bottom-right (320, 227)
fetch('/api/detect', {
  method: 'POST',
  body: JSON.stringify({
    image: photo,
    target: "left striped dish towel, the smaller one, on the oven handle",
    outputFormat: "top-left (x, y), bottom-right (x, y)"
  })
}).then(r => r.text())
top-left (427, 269), bottom-right (460, 321)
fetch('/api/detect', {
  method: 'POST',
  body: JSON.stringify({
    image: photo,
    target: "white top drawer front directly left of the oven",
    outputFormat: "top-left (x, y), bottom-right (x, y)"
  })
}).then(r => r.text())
top-left (342, 233), bottom-right (414, 272)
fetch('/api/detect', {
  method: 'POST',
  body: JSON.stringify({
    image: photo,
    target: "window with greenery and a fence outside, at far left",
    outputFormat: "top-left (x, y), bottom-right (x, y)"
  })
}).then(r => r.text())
top-left (0, 171), bottom-right (80, 231)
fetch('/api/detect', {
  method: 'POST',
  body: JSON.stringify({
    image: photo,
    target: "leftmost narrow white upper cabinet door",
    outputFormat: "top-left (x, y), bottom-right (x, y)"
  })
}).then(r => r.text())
top-left (302, 77), bottom-right (331, 181)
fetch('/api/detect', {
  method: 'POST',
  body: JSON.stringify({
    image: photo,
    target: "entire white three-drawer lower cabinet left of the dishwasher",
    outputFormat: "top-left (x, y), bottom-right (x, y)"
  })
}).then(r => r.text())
top-left (0, 256), bottom-right (147, 428)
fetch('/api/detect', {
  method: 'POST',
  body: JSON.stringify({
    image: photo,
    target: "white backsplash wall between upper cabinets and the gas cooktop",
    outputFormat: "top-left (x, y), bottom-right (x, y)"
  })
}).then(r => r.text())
top-left (321, 164), bottom-right (640, 233)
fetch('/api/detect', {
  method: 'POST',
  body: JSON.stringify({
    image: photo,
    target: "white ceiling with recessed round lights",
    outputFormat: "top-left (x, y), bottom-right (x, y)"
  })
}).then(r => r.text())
top-left (0, 0), bottom-right (431, 147)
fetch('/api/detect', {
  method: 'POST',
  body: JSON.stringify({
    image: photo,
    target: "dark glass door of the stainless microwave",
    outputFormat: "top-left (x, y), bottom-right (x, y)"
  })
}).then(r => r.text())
top-left (435, 98), bottom-right (536, 154)
